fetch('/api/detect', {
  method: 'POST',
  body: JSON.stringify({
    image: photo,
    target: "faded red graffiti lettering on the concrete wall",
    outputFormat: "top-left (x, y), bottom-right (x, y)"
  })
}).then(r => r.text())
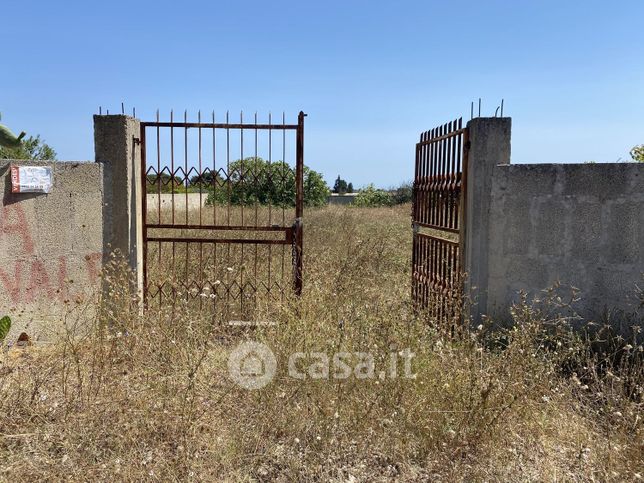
top-left (0, 204), bottom-right (103, 304)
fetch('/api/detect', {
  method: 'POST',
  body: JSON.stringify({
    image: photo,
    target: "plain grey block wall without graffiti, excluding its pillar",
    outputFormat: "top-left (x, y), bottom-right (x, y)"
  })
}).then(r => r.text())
top-left (486, 163), bottom-right (644, 332)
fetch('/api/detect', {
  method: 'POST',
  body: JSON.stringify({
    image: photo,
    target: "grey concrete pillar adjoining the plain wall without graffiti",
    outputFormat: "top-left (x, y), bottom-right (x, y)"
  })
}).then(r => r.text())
top-left (464, 117), bottom-right (512, 325)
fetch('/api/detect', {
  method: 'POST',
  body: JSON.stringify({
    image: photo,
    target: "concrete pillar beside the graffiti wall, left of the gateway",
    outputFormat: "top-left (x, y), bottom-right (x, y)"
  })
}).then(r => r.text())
top-left (94, 115), bottom-right (143, 293)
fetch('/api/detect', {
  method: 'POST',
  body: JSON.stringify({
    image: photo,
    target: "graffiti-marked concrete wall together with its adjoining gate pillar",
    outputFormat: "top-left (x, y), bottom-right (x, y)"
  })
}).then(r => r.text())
top-left (0, 115), bottom-right (143, 342)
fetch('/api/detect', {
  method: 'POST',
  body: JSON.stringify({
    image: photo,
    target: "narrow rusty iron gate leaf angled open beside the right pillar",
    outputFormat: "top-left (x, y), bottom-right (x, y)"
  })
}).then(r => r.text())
top-left (412, 118), bottom-right (469, 322)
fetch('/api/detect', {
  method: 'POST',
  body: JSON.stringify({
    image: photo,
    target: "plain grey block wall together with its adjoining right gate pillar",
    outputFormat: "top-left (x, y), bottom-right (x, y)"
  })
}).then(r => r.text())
top-left (465, 118), bottom-right (644, 333)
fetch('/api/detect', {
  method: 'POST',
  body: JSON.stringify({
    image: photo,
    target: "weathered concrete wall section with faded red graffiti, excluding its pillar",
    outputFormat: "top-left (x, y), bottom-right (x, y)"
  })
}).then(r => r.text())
top-left (0, 160), bottom-right (104, 340)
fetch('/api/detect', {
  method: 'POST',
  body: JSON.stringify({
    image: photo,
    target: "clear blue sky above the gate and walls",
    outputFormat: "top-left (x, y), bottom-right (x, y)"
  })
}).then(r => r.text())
top-left (0, 0), bottom-right (644, 186)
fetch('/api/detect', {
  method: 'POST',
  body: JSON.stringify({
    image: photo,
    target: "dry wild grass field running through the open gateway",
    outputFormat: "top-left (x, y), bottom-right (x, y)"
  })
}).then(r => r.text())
top-left (0, 205), bottom-right (644, 482)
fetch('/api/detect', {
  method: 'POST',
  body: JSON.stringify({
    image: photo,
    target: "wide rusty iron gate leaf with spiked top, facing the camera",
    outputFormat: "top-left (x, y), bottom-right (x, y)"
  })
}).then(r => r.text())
top-left (140, 112), bottom-right (305, 320)
